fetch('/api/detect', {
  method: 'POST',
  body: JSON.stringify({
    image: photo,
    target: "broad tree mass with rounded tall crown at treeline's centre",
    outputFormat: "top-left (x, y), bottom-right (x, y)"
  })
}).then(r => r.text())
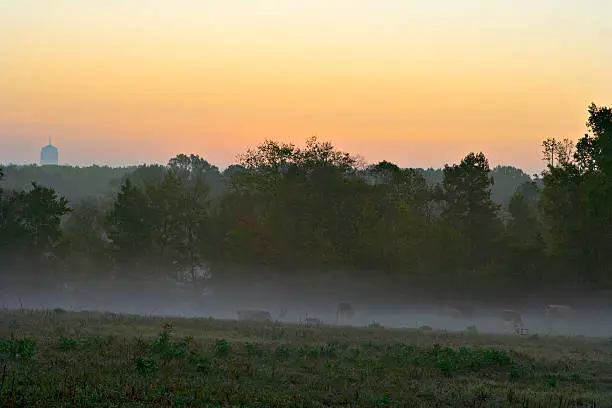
top-left (226, 138), bottom-right (361, 266)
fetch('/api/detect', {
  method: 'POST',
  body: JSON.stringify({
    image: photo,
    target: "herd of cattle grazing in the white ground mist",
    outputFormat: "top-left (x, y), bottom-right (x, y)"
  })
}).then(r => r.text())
top-left (237, 302), bottom-right (576, 334)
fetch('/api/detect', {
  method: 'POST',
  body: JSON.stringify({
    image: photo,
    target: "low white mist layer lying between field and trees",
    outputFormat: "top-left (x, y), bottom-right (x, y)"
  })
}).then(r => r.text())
top-left (0, 280), bottom-right (612, 337)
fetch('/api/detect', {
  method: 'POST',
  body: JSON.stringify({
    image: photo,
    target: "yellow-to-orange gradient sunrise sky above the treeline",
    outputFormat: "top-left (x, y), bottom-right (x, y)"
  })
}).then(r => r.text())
top-left (0, 0), bottom-right (612, 172)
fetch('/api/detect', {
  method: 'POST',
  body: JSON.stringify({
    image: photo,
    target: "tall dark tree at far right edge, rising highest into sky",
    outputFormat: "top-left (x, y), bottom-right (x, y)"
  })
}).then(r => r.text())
top-left (539, 104), bottom-right (612, 285)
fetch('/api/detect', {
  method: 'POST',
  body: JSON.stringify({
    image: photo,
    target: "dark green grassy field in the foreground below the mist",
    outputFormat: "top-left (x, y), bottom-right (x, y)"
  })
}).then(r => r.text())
top-left (0, 309), bottom-right (612, 407)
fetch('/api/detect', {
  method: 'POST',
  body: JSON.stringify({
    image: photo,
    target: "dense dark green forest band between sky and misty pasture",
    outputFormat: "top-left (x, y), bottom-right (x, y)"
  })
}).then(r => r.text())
top-left (0, 104), bottom-right (612, 304)
